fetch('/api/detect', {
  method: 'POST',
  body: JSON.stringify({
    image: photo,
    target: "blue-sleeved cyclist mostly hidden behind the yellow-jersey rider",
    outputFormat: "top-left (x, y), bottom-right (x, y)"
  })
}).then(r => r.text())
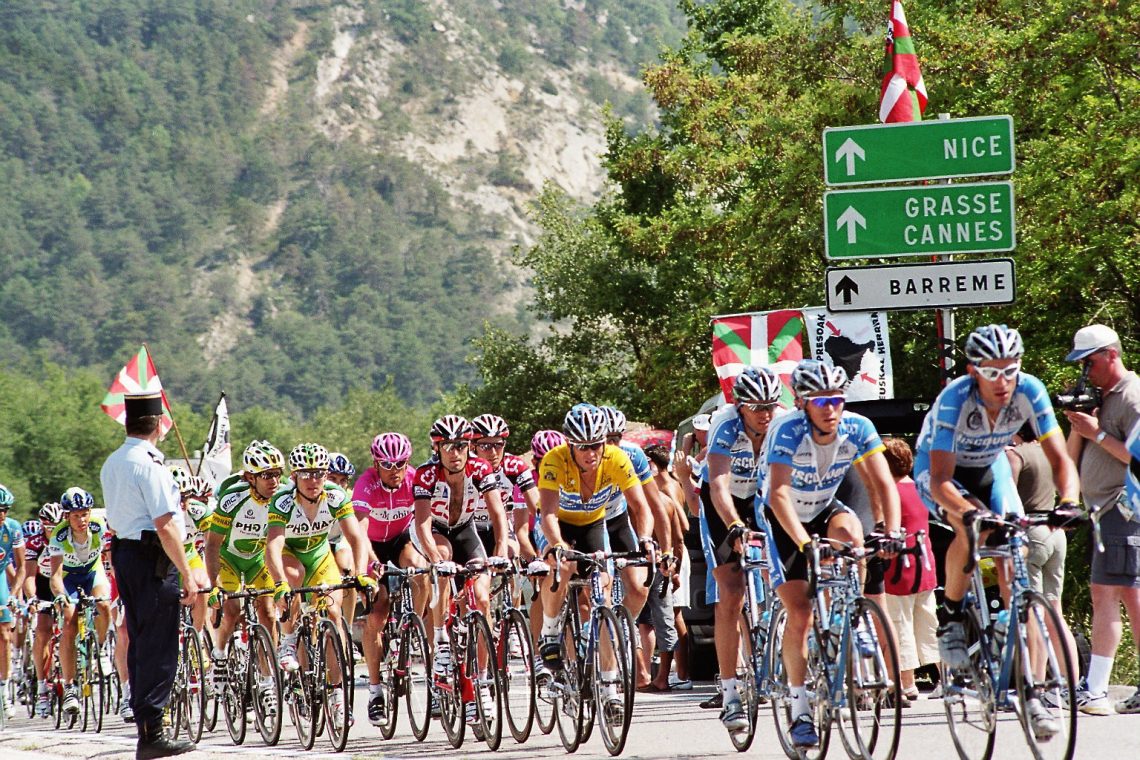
top-left (599, 407), bottom-right (673, 620)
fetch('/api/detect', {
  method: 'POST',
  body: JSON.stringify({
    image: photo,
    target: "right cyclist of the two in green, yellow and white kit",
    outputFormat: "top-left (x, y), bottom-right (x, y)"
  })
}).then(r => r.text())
top-left (266, 443), bottom-right (376, 729)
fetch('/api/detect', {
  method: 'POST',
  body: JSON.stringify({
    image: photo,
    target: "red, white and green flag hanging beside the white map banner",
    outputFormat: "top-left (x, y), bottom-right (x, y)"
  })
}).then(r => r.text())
top-left (713, 309), bottom-right (804, 408)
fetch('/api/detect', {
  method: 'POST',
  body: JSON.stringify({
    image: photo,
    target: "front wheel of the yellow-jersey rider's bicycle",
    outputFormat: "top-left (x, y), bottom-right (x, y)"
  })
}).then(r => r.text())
top-left (591, 607), bottom-right (634, 755)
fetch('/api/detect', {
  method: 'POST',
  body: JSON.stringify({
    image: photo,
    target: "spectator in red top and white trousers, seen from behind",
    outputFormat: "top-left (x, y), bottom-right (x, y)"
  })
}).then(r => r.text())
top-left (882, 438), bottom-right (939, 708)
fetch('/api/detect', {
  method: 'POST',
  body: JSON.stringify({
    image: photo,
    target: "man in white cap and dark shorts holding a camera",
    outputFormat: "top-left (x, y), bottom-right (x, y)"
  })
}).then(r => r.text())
top-left (1058, 325), bottom-right (1140, 716)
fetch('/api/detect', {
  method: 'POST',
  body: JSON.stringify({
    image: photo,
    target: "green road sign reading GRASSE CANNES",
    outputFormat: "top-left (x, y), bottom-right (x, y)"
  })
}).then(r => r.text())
top-left (823, 182), bottom-right (1017, 259)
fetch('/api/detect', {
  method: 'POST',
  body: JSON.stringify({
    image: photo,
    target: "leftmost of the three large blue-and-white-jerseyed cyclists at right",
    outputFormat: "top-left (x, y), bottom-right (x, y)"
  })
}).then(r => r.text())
top-left (699, 367), bottom-right (783, 732)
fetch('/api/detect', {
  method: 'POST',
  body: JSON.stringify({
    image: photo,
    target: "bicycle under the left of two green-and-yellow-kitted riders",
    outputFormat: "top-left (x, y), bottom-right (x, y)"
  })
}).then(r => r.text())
top-left (213, 585), bottom-right (282, 746)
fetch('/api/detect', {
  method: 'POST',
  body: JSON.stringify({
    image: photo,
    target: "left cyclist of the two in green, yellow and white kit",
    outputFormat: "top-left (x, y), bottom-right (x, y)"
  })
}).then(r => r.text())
top-left (205, 441), bottom-right (285, 694)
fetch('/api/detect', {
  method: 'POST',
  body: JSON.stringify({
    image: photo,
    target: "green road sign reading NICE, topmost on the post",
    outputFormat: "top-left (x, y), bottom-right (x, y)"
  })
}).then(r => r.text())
top-left (823, 116), bottom-right (1013, 185)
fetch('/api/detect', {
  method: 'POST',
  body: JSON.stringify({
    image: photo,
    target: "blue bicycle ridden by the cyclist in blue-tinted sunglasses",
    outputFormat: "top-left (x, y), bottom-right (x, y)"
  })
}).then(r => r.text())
top-left (773, 536), bottom-right (902, 760)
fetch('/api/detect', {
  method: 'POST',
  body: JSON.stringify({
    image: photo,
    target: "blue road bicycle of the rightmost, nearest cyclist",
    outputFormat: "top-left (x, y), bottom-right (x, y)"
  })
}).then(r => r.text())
top-left (942, 509), bottom-right (1101, 760)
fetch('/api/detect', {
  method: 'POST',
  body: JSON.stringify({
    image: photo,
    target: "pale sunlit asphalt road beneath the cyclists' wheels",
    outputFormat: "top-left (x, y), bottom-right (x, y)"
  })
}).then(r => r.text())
top-left (0, 685), bottom-right (1140, 760)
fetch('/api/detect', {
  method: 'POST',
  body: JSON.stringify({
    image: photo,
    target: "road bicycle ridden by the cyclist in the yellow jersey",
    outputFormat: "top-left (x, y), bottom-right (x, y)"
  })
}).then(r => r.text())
top-left (549, 547), bottom-right (644, 755)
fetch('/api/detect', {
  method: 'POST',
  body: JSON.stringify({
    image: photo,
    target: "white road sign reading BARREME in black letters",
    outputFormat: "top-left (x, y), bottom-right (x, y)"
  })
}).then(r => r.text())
top-left (827, 259), bottom-right (1015, 311)
